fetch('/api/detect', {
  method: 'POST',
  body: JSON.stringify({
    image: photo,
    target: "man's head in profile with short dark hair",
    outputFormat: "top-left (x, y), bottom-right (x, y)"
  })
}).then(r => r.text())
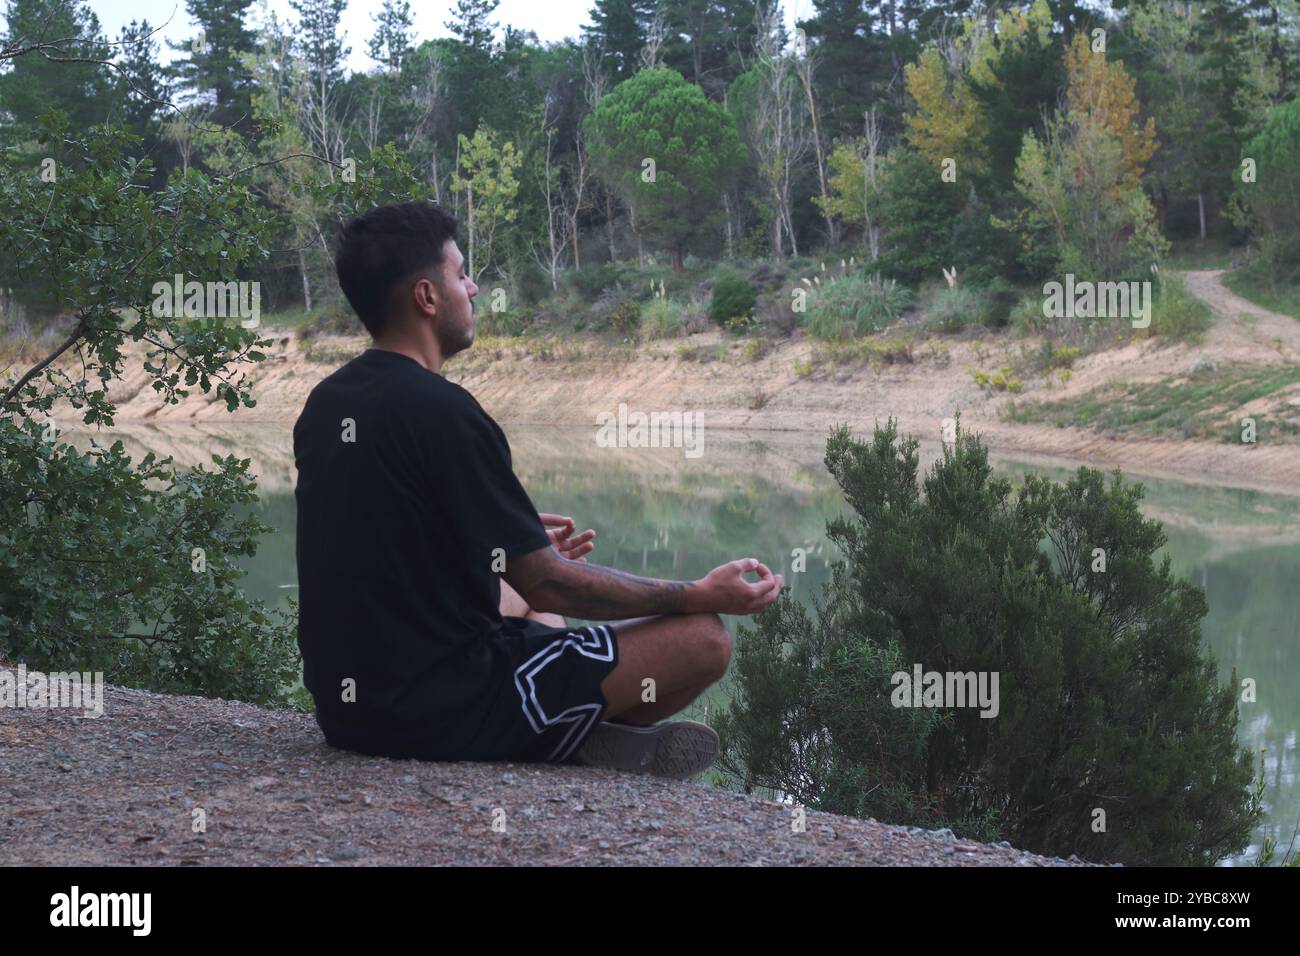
top-left (334, 202), bottom-right (478, 359)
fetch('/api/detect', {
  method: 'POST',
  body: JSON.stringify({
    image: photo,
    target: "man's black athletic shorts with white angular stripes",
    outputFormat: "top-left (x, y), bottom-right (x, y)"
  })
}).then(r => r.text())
top-left (460, 617), bottom-right (619, 763)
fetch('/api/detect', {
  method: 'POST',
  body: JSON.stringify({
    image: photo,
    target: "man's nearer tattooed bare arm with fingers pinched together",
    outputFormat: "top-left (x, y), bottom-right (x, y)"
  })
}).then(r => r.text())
top-left (504, 548), bottom-right (783, 620)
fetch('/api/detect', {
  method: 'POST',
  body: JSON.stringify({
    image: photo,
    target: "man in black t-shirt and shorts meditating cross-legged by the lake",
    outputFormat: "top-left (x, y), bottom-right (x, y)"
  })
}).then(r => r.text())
top-left (294, 202), bottom-right (781, 779)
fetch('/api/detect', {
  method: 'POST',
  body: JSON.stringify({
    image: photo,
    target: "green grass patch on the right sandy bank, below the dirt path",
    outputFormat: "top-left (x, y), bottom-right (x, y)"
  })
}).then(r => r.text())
top-left (1004, 365), bottom-right (1300, 444)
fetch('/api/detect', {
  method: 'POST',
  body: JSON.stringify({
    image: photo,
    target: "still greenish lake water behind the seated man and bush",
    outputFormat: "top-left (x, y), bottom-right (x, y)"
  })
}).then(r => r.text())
top-left (65, 425), bottom-right (1300, 864)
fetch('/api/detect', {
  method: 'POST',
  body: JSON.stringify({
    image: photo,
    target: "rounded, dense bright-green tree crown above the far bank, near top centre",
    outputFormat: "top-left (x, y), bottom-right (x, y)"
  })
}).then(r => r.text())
top-left (584, 68), bottom-right (744, 272)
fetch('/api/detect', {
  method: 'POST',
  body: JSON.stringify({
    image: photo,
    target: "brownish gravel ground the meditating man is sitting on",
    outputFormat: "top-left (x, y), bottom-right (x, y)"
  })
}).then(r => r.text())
top-left (0, 671), bottom-right (1102, 866)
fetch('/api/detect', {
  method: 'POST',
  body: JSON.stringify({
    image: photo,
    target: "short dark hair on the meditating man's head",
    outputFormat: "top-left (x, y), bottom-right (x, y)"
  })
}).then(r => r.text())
top-left (334, 200), bottom-right (456, 338)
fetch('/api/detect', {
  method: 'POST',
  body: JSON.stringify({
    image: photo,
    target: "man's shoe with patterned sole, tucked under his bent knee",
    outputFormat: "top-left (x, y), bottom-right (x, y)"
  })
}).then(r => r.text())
top-left (577, 721), bottom-right (719, 780)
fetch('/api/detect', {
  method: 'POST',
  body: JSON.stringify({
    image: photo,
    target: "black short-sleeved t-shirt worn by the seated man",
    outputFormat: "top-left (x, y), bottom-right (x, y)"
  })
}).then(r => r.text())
top-left (294, 349), bottom-right (550, 753)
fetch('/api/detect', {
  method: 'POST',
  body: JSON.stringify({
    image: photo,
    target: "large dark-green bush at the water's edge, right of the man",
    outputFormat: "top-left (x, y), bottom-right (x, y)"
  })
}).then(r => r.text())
top-left (716, 421), bottom-right (1258, 866)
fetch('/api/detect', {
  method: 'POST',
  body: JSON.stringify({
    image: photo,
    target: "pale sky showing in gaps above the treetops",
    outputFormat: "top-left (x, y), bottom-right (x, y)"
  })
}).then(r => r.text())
top-left (58, 0), bottom-right (813, 72)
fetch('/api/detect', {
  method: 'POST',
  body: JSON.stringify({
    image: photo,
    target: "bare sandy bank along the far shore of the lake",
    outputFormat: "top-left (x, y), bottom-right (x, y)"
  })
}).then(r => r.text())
top-left (30, 271), bottom-right (1300, 492)
